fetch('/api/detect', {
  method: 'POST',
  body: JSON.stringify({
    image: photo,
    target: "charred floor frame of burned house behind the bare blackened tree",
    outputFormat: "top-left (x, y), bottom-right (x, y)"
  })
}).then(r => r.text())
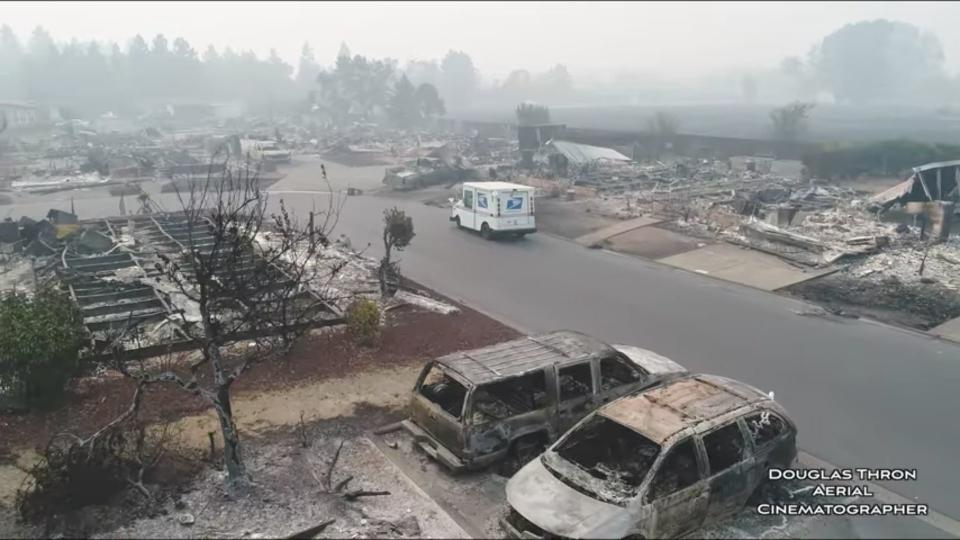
top-left (0, 211), bottom-right (342, 358)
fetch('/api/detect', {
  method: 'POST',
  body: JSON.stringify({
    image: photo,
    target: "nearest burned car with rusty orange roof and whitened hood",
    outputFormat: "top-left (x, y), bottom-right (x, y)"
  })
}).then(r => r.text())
top-left (501, 375), bottom-right (797, 538)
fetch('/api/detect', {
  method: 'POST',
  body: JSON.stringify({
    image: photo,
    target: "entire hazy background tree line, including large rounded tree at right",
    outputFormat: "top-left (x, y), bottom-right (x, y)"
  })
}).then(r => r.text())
top-left (0, 20), bottom-right (960, 133)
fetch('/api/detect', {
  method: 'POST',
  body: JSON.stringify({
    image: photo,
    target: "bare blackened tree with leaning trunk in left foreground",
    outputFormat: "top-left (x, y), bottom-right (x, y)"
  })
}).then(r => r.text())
top-left (107, 161), bottom-right (346, 484)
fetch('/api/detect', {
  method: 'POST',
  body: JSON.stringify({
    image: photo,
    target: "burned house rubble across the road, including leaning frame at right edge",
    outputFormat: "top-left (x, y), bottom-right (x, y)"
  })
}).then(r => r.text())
top-left (520, 150), bottom-right (960, 329)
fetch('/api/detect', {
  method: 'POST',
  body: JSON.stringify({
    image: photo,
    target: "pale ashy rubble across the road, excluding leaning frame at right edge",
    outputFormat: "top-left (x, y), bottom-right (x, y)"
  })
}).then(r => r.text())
top-left (540, 155), bottom-right (960, 326)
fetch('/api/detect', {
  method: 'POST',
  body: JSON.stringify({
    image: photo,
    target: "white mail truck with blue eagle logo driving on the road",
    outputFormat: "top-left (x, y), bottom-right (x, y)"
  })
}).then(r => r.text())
top-left (450, 182), bottom-right (537, 238)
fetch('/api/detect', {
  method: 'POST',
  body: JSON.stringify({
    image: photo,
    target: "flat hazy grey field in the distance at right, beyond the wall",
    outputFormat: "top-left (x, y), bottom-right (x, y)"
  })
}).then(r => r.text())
top-left (450, 104), bottom-right (960, 143)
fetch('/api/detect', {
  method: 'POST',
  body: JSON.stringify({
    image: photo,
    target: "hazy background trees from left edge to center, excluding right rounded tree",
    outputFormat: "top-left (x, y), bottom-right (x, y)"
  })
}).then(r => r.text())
top-left (0, 25), bottom-right (573, 126)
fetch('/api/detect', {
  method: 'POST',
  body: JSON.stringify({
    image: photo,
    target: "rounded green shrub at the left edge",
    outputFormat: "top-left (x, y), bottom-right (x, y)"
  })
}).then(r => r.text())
top-left (0, 289), bottom-right (85, 406)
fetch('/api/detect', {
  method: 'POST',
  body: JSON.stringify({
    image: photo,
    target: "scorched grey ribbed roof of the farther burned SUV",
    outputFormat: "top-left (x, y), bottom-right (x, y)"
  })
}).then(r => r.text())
top-left (436, 330), bottom-right (616, 385)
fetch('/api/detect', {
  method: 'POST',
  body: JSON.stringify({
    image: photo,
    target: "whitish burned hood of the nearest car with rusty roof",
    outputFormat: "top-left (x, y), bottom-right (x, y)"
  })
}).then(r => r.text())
top-left (506, 459), bottom-right (630, 538)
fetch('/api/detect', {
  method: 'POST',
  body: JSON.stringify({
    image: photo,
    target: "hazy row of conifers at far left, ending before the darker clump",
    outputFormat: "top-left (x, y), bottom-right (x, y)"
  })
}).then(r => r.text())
top-left (0, 25), bottom-right (302, 113)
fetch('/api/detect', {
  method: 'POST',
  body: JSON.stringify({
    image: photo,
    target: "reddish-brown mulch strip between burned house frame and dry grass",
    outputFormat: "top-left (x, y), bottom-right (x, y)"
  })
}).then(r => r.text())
top-left (0, 287), bottom-right (520, 460)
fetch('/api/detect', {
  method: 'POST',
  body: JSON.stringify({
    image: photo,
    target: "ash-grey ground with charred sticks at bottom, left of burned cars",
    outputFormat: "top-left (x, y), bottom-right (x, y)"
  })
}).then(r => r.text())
top-left (89, 417), bottom-right (465, 538)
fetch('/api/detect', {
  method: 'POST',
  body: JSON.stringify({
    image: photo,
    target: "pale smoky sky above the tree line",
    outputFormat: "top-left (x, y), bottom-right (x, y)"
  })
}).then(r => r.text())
top-left (0, 2), bottom-right (960, 79)
